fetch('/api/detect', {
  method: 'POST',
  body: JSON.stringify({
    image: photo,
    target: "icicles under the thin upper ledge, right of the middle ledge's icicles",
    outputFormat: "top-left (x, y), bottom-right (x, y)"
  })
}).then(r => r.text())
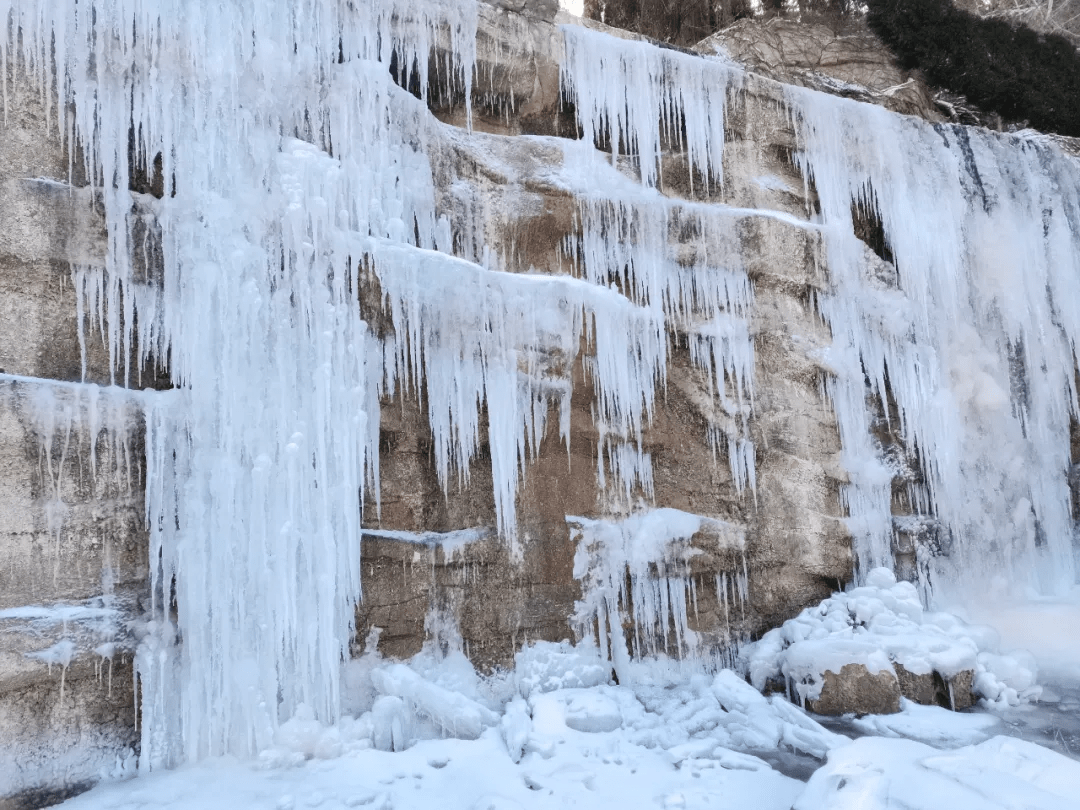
top-left (568, 173), bottom-right (757, 494)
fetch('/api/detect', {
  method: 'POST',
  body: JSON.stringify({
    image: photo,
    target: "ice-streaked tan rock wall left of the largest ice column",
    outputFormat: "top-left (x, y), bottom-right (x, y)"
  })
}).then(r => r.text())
top-left (0, 58), bottom-right (148, 810)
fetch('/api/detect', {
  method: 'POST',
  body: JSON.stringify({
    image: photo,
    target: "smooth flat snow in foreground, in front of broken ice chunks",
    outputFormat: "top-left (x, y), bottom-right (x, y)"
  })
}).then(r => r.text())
top-left (64, 729), bottom-right (802, 810)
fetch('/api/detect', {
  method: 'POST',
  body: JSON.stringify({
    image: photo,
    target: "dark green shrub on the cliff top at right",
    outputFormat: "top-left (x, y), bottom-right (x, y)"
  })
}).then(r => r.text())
top-left (867, 0), bottom-right (1080, 136)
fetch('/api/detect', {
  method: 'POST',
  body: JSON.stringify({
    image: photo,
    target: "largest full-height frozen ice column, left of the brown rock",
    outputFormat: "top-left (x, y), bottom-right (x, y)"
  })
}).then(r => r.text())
top-left (0, 0), bottom-right (476, 767)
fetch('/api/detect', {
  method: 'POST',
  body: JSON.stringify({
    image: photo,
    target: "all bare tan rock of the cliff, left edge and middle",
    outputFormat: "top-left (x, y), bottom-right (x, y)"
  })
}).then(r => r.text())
top-left (0, 0), bottom-right (946, 808)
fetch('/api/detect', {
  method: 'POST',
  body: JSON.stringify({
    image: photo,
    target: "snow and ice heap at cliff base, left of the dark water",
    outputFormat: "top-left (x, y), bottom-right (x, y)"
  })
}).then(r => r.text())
top-left (54, 643), bottom-right (812, 810)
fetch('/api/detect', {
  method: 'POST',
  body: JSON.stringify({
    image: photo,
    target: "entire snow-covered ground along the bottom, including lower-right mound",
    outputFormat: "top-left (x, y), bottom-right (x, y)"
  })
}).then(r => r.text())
top-left (56, 613), bottom-right (1080, 810)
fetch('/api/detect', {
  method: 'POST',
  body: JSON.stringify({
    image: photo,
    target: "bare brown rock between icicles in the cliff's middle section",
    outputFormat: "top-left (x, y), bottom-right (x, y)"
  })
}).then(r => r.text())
top-left (357, 6), bottom-right (851, 665)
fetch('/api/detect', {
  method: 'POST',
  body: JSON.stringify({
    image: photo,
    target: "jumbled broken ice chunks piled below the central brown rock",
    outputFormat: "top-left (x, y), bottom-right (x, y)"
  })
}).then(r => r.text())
top-left (336, 639), bottom-right (850, 770)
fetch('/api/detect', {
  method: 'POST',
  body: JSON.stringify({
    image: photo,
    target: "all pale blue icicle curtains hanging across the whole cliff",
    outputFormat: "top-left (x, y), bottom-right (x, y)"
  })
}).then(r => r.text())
top-left (6, 0), bottom-right (1080, 767)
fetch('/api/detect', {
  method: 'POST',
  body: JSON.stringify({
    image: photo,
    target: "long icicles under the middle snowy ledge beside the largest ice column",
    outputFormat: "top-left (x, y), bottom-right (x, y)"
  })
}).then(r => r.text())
top-left (369, 241), bottom-right (666, 549)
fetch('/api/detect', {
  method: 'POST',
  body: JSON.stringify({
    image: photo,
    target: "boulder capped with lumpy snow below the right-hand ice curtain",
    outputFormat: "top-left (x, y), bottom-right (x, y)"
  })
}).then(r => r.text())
top-left (744, 568), bottom-right (1041, 714)
